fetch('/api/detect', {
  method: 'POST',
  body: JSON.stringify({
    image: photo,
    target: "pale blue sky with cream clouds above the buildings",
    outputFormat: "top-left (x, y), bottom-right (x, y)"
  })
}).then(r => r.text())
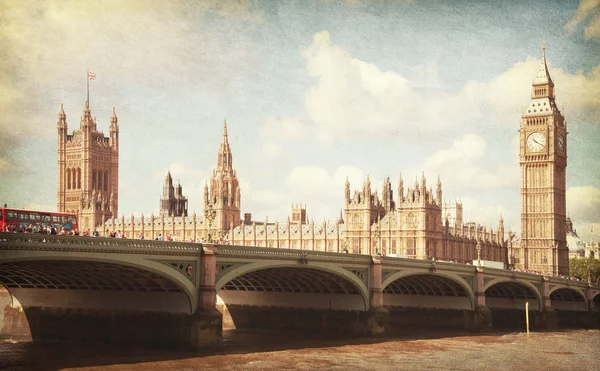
top-left (0, 0), bottom-right (600, 241)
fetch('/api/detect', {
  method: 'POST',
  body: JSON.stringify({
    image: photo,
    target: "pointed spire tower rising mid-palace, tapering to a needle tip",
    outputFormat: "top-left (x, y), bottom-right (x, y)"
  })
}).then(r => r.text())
top-left (204, 120), bottom-right (241, 231)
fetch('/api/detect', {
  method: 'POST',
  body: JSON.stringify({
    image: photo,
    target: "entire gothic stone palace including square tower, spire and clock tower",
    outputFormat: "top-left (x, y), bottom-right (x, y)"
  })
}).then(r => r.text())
top-left (57, 48), bottom-right (569, 274)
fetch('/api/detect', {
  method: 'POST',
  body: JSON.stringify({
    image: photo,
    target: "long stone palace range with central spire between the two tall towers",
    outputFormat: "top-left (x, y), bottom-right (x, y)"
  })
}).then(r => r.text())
top-left (106, 122), bottom-right (510, 263)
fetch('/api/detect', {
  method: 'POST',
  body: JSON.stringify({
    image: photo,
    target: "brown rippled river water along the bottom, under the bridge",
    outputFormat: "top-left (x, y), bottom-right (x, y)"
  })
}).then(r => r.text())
top-left (0, 330), bottom-right (600, 371)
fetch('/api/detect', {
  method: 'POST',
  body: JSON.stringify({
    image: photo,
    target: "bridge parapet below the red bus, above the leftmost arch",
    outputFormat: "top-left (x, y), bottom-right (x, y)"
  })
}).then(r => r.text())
top-left (0, 232), bottom-right (202, 254)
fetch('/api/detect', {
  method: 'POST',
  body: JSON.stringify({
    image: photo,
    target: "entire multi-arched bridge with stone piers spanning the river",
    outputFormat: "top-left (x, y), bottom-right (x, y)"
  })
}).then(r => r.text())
top-left (0, 233), bottom-right (600, 348)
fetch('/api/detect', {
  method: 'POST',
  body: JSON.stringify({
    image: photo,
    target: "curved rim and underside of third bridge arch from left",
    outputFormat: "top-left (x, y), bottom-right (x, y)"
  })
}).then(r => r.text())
top-left (381, 269), bottom-right (475, 310)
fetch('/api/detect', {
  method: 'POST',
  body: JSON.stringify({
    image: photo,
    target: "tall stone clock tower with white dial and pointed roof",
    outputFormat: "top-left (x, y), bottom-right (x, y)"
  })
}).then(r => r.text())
top-left (515, 46), bottom-right (569, 275)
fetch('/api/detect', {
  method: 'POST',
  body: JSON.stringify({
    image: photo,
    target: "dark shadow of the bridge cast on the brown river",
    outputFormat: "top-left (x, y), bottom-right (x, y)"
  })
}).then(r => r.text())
top-left (0, 329), bottom-right (532, 371)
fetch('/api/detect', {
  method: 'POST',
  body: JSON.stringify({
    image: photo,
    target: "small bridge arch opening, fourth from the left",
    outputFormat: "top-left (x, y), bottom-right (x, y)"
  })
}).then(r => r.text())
top-left (483, 278), bottom-right (543, 310)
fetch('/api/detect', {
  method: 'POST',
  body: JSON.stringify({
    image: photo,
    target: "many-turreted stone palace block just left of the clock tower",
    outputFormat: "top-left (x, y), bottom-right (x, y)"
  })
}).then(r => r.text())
top-left (343, 174), bottom-right (508, 262)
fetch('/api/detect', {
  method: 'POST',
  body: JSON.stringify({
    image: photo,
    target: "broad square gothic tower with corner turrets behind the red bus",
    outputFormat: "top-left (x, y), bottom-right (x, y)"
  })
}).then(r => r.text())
top-left (57, 101), bottom-right (119, 231)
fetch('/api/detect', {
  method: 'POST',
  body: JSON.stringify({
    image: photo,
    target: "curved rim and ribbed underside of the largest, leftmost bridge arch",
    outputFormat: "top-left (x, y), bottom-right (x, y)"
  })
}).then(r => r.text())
top-left (0, 251), bottom-right (199, 313)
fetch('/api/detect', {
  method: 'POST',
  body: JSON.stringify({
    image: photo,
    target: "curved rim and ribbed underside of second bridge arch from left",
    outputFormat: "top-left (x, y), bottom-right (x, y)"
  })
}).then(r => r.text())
top-left (215, 261), bottom-right (369, 311)
